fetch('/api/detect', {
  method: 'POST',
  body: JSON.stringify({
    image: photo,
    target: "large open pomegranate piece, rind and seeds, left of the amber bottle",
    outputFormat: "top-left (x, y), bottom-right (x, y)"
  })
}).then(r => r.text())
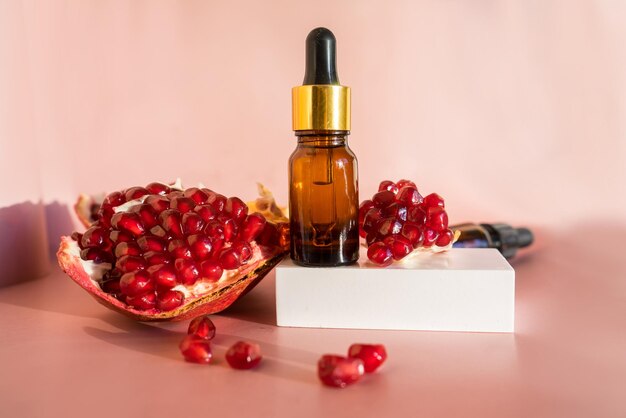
top-left (57, 182), bottom-right (288, 321)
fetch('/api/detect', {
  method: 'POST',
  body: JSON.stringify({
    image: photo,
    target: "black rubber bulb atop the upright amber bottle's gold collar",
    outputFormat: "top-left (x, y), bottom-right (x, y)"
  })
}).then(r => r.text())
top-left (302, 28), bottom-right (339, 86)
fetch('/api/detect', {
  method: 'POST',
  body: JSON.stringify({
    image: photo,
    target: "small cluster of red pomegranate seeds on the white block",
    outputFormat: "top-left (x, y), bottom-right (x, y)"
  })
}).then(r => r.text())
top-left (359, 180), bottom-right (454, 266)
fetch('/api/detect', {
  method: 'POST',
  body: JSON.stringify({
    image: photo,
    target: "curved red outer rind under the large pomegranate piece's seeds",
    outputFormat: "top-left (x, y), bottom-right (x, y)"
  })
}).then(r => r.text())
top-left (57, 236), bottom-right (285, 322)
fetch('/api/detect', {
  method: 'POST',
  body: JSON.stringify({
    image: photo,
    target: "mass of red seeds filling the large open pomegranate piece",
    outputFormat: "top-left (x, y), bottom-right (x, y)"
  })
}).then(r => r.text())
top-left (72, 183), bottom-right (270, 311)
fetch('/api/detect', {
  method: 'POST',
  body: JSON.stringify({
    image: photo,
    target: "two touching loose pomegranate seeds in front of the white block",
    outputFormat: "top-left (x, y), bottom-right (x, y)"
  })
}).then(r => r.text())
top-left (317, 344), bottom-right (387, 388)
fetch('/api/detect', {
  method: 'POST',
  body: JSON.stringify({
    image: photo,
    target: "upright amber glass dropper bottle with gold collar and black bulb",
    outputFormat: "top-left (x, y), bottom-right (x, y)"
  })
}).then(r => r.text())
top-left (289, 28), bottom-right (359, 267)
